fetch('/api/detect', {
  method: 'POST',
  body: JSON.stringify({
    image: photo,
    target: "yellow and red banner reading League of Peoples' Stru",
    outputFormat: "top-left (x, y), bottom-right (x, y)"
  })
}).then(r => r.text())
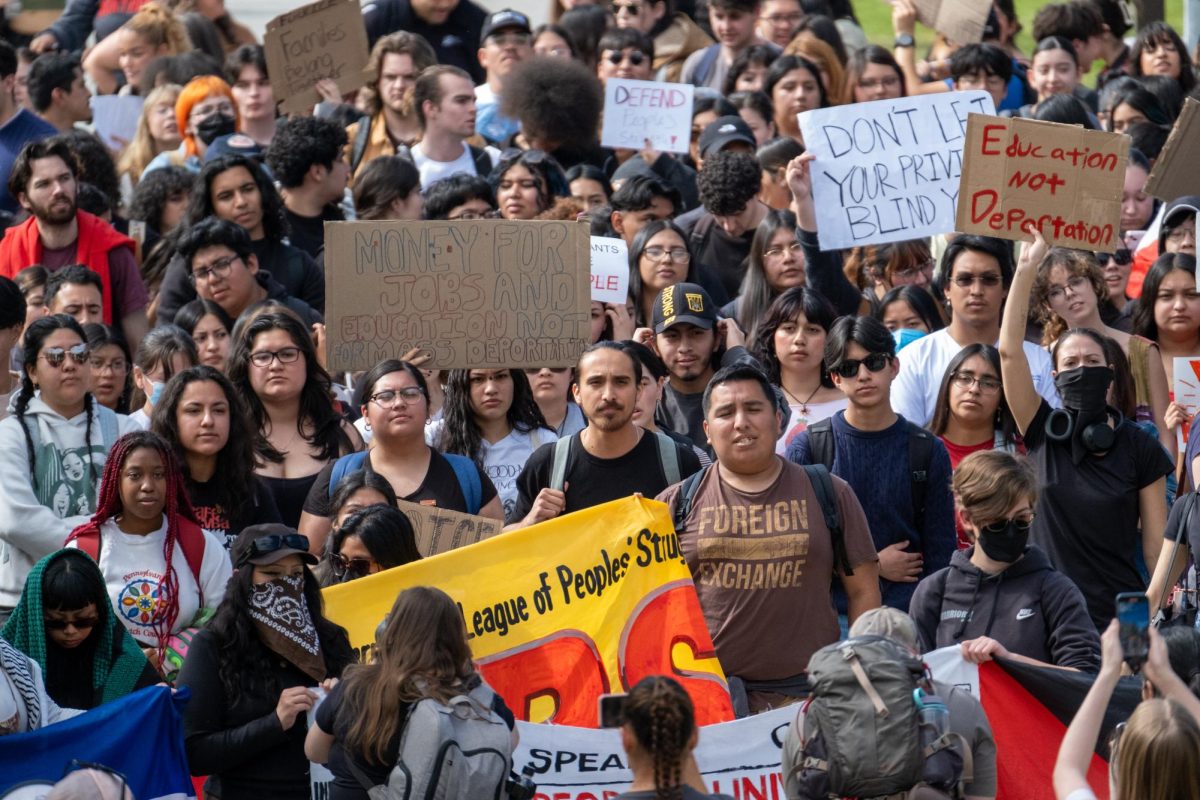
top-left (324, 497), bottom-right (733, 728)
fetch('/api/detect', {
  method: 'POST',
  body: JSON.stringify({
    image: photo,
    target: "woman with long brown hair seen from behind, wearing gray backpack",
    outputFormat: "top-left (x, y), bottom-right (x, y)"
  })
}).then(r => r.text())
top-left (307, 587), bottom-right (517, 800)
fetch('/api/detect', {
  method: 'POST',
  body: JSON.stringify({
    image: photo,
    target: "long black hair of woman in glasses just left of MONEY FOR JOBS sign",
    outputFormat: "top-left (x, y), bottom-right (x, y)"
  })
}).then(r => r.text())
top-left (227, 302), bottom-right (354, 464)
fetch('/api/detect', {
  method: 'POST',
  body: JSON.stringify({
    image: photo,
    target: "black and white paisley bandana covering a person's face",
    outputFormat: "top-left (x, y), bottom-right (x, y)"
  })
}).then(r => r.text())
top-left (250, 575), bottom-right (325, 681)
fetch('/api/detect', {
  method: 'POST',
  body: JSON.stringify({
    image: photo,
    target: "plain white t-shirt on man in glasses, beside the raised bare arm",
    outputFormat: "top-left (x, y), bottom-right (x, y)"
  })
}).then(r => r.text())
top-left (892, 327), bottom-right (1062, 426)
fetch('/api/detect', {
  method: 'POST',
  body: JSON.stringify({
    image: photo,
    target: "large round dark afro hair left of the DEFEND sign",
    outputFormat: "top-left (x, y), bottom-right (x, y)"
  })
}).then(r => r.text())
top-left (500, 56), bottom-right (604, 151)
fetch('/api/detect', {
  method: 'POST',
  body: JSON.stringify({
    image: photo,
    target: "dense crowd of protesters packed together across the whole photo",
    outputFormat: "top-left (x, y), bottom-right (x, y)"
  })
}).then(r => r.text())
top-left (0, 0), bottom-right (1200, 800)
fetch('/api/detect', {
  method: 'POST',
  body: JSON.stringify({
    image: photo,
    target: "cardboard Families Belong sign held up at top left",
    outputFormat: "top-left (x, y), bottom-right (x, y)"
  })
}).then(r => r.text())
top-left (263, 0), bottom-right (370, 114)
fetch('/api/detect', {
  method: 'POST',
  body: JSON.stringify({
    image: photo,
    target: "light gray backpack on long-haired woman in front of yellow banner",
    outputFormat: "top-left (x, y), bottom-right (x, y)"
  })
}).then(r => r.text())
top-left (352, 681), bottom-right (512, 800)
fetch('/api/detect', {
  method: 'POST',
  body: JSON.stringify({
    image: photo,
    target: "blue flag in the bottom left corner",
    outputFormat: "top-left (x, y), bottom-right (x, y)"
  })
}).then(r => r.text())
top-left (0, 686), bottom-right (196, 800)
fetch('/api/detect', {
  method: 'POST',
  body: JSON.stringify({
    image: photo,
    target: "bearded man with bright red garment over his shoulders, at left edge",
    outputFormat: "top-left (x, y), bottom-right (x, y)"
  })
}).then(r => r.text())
top-left (0, 138), bottom-right (149, 342)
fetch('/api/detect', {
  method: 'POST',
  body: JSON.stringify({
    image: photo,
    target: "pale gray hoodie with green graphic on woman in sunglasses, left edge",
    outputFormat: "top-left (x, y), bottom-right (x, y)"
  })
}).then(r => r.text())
top-left (0, 395), bottom-right (137, 610)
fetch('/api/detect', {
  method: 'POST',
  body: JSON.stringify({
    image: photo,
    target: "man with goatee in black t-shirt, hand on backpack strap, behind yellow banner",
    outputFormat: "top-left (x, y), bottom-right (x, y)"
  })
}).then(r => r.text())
top-left (505, 342), bottom-right (700, 530)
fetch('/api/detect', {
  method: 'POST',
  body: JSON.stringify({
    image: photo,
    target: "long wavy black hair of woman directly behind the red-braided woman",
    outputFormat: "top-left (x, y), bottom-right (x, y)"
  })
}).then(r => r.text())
top-left (150, 365), bottom-right (258, 524)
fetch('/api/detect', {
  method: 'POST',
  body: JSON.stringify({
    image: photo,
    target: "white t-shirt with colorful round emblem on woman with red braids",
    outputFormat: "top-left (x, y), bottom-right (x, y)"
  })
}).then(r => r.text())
top-left (71, 516), bottom-right (233, 646)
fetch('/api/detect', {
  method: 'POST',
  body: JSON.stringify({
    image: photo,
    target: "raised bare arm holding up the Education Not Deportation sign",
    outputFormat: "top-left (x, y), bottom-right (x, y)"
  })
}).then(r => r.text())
top-left (1000, 224), bottom-right (1046, 434)
